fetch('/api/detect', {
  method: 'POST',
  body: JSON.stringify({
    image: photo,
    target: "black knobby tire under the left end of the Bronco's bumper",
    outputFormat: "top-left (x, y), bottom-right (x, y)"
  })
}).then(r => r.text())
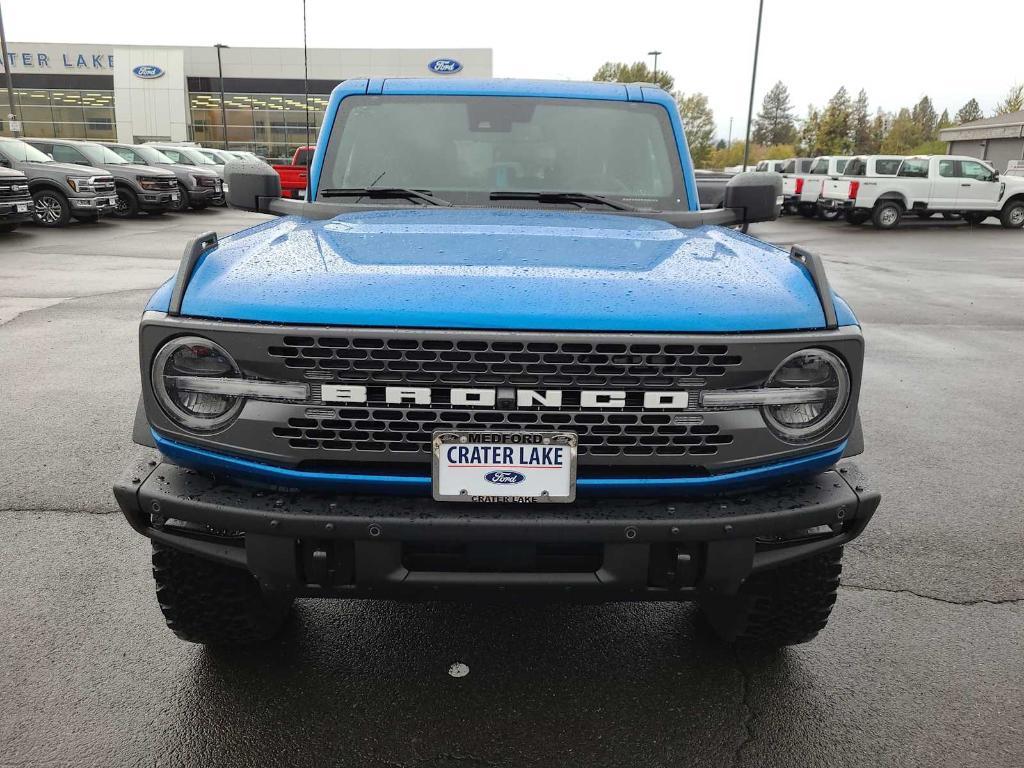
top-left (153, 542), bottom-right (292, 646)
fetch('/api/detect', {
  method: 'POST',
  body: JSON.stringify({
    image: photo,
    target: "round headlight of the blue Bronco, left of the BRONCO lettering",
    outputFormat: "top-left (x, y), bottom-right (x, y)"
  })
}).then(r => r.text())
top-left (152, 336), bottom-right (243, 432)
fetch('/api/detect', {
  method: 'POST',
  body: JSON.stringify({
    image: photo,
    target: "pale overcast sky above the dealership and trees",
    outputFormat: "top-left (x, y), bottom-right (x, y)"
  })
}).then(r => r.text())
top-left (0, 0), bottom-right (1024, 138)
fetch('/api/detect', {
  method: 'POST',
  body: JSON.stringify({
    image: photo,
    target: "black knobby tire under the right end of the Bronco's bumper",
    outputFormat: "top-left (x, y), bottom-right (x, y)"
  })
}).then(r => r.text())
top-left (701, 547), bottom-right (843, 649)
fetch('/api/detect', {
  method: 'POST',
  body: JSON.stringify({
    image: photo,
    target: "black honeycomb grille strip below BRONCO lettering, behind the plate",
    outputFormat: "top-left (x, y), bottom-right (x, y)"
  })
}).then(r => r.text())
top-left (272, 408), bottom-right (733, 457)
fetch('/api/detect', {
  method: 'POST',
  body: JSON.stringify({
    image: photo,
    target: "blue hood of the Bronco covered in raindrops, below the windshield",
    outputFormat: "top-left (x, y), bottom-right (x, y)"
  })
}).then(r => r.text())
top-left (150, 208), bottom-right (855, 333)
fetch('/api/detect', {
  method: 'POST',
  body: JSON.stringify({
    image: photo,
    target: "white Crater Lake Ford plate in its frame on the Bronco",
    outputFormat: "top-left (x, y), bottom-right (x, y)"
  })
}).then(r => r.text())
top-left (433, 430), bottom-right (577, 504)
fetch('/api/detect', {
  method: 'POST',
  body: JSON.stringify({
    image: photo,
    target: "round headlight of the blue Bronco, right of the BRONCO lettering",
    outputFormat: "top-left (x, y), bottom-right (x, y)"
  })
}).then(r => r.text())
top-left (762, 349), bottom-right (850, 442)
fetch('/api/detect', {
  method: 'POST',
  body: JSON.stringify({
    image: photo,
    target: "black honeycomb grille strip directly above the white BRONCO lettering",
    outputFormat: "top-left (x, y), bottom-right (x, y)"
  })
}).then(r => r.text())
top-left (267, 336), bottom-right (742, 388)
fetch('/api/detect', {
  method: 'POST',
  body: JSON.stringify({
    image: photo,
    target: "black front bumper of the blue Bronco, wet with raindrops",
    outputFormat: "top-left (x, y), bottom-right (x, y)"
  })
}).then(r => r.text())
top-left (114, 451), bottom-right (880, 600)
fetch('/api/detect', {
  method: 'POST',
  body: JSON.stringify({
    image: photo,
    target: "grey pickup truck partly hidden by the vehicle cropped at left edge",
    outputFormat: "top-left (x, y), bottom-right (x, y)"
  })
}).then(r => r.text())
top-left (0, 137), bottom-right (118, 226)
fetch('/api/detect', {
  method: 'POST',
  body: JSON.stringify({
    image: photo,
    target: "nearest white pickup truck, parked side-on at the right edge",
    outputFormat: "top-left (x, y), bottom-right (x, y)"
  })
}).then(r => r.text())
top-left (819, 155), bottom-right (1024, 229)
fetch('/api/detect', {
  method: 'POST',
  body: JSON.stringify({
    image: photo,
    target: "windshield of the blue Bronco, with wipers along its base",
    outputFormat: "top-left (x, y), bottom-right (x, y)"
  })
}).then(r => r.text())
top-left (318, 96), bottom-right (686, 210)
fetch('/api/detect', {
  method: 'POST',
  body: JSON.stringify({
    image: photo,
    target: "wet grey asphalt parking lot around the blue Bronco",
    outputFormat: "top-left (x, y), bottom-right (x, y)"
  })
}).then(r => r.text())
top-left (0, 210), bottom-right (1024, 768)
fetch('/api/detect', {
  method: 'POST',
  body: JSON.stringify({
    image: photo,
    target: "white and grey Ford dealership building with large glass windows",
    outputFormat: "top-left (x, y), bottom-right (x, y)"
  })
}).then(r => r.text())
top-left (0, 42), bottom-right (492, 158)
